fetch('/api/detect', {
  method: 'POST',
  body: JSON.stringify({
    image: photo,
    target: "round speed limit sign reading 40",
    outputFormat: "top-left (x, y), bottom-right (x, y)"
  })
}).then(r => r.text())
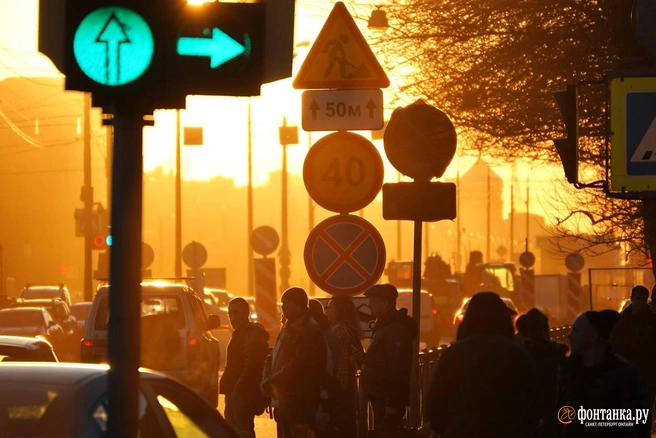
top-left (303, 132), bottom-right (384, 213)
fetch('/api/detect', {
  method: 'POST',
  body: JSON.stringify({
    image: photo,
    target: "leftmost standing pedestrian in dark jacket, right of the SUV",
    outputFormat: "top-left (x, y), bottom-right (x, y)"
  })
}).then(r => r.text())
top-left (219, 297), bottom-right (269, 438)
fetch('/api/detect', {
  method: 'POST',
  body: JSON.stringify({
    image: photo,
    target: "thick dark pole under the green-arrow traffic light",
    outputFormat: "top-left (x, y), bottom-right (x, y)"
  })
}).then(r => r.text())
top-left (107, 102), bottom-right (146, 438)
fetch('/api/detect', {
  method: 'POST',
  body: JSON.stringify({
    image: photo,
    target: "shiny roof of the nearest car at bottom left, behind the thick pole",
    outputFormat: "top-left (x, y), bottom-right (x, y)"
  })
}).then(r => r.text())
top-left (0, 362), bottom-right (165, 385)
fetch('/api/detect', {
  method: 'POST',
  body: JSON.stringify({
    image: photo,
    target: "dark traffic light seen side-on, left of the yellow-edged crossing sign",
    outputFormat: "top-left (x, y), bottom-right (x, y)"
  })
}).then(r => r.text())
top-left (551, 85), bottom-right (579, 184)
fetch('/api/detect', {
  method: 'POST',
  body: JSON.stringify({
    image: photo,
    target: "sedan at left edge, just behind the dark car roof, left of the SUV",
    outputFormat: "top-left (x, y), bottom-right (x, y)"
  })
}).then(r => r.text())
top-left (0, 307), bottom-right (64, 354)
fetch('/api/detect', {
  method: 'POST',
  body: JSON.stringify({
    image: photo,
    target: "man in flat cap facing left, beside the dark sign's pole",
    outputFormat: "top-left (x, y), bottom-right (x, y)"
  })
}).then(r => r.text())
top-left (360, 283), bottom-right (419, 437)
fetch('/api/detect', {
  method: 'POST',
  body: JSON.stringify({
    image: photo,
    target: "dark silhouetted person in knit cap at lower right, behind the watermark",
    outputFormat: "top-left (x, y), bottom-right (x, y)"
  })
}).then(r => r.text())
top-left (557, 310), bottom-right (649, 438)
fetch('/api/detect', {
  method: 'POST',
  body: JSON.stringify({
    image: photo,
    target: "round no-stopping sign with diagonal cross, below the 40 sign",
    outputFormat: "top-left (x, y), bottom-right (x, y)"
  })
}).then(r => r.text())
top-left (303, 214), bottom-right (386, 295)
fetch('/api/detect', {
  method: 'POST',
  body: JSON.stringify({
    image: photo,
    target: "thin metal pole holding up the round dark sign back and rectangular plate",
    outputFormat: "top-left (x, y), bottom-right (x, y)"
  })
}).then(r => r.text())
top-left (410, 221), bottom-right (422, 427)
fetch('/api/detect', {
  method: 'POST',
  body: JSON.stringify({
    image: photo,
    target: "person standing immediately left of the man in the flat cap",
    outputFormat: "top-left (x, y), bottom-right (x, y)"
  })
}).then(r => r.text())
top-left (326, 295), bottom-right (364, 438)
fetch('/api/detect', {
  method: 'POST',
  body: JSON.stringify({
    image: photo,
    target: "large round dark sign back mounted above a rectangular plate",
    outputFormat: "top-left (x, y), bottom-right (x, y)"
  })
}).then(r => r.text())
top-left (383, 101), bottom-right (458, 181)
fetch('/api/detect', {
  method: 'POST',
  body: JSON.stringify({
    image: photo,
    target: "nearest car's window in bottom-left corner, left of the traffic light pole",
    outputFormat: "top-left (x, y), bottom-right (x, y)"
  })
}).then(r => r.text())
top-left (0, 379), bottom-right (69, 437)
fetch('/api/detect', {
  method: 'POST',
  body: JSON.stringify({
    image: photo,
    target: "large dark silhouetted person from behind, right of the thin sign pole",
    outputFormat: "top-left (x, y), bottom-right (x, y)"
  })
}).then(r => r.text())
top-left (423, 291), bottom-right (540, 438)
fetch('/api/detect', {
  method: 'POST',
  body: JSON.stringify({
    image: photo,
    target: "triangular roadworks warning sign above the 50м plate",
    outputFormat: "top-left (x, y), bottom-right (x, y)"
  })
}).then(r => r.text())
top-left (292, 2), bottom-right (390, 90)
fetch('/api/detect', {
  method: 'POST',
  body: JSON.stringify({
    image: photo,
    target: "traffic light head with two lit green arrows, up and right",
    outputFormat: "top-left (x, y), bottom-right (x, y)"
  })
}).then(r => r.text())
top-left (63, 0), bottom-right (265, 109)
